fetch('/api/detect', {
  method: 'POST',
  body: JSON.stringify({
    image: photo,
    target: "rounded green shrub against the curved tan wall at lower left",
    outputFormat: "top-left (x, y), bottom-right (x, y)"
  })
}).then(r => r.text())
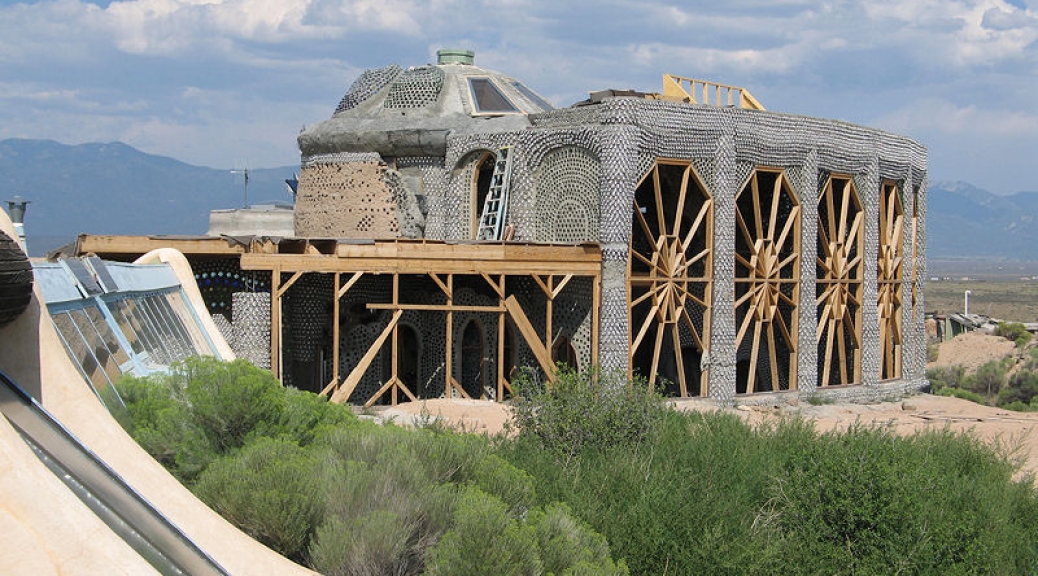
top-left (195, 438), bottom-right (324, 561)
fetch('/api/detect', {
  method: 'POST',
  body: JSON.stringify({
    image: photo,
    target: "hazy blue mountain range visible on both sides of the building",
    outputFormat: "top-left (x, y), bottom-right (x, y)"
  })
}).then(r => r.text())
top-left (0, 139), bottom-right (1038, 260)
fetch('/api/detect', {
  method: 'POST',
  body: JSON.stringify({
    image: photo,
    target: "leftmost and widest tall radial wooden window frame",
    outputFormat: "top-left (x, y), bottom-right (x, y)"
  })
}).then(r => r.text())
top-left (627, 160), bottom-right (713, 396)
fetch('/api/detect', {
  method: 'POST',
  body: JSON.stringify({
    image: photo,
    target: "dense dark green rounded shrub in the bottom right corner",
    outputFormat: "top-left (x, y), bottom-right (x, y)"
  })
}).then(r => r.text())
top-left (758, 427), bottom-right (1038, 574)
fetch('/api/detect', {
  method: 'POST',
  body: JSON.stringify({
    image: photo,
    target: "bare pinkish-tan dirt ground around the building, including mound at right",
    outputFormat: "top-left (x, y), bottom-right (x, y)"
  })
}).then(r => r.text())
top-left (375, 333), bottom-right (1038, 475)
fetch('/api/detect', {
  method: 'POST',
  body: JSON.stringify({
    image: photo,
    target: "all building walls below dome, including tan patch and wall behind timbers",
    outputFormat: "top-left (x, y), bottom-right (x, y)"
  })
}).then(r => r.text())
top-left (288, 93), bottom-right (927, 403)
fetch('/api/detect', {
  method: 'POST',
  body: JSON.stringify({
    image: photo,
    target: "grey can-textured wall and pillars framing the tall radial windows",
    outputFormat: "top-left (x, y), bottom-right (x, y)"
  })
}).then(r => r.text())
top-left (442, 99), bottom-right (926, 402)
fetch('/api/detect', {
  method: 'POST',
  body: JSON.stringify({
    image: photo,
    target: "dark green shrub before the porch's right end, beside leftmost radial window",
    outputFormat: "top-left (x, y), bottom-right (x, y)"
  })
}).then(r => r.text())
top-left (511, 365), bottom-right (667, 467)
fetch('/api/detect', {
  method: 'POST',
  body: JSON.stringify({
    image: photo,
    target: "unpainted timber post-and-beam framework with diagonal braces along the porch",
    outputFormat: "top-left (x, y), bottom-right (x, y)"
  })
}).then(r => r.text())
top-left (241, 240), bottom-right (602, 406)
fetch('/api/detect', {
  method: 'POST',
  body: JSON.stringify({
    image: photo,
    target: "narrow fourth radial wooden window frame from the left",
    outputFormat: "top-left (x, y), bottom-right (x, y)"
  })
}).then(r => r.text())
top-left (877, 181), bottom-right (904, 380)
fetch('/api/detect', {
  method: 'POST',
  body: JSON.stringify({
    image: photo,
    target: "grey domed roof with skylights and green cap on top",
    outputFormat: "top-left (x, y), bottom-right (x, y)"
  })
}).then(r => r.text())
top-left (299, 50), bottom-right (553, 157)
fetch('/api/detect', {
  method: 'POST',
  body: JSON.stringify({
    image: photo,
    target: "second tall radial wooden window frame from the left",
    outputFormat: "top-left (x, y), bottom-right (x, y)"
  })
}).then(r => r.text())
top-left (734, 168), bottom-right (800, 393)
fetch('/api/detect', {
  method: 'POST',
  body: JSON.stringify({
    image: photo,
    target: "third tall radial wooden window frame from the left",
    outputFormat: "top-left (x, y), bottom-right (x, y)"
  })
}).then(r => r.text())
top-left (815, 175), bottom-right (865, 386)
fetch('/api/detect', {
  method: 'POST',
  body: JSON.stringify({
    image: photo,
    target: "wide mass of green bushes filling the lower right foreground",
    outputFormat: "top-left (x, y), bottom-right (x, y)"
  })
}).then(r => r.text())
top-left (499, 412), bottom-right (1038, 574)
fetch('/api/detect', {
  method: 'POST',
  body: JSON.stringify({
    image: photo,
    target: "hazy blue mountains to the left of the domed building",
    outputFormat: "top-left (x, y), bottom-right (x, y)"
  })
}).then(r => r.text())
top-left (0, 139), bottom-right (299, 256)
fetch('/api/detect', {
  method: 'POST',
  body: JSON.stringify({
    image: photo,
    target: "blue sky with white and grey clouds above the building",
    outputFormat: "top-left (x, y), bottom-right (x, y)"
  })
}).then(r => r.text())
top-left (0, 0), bottom-right (1038, 193)
